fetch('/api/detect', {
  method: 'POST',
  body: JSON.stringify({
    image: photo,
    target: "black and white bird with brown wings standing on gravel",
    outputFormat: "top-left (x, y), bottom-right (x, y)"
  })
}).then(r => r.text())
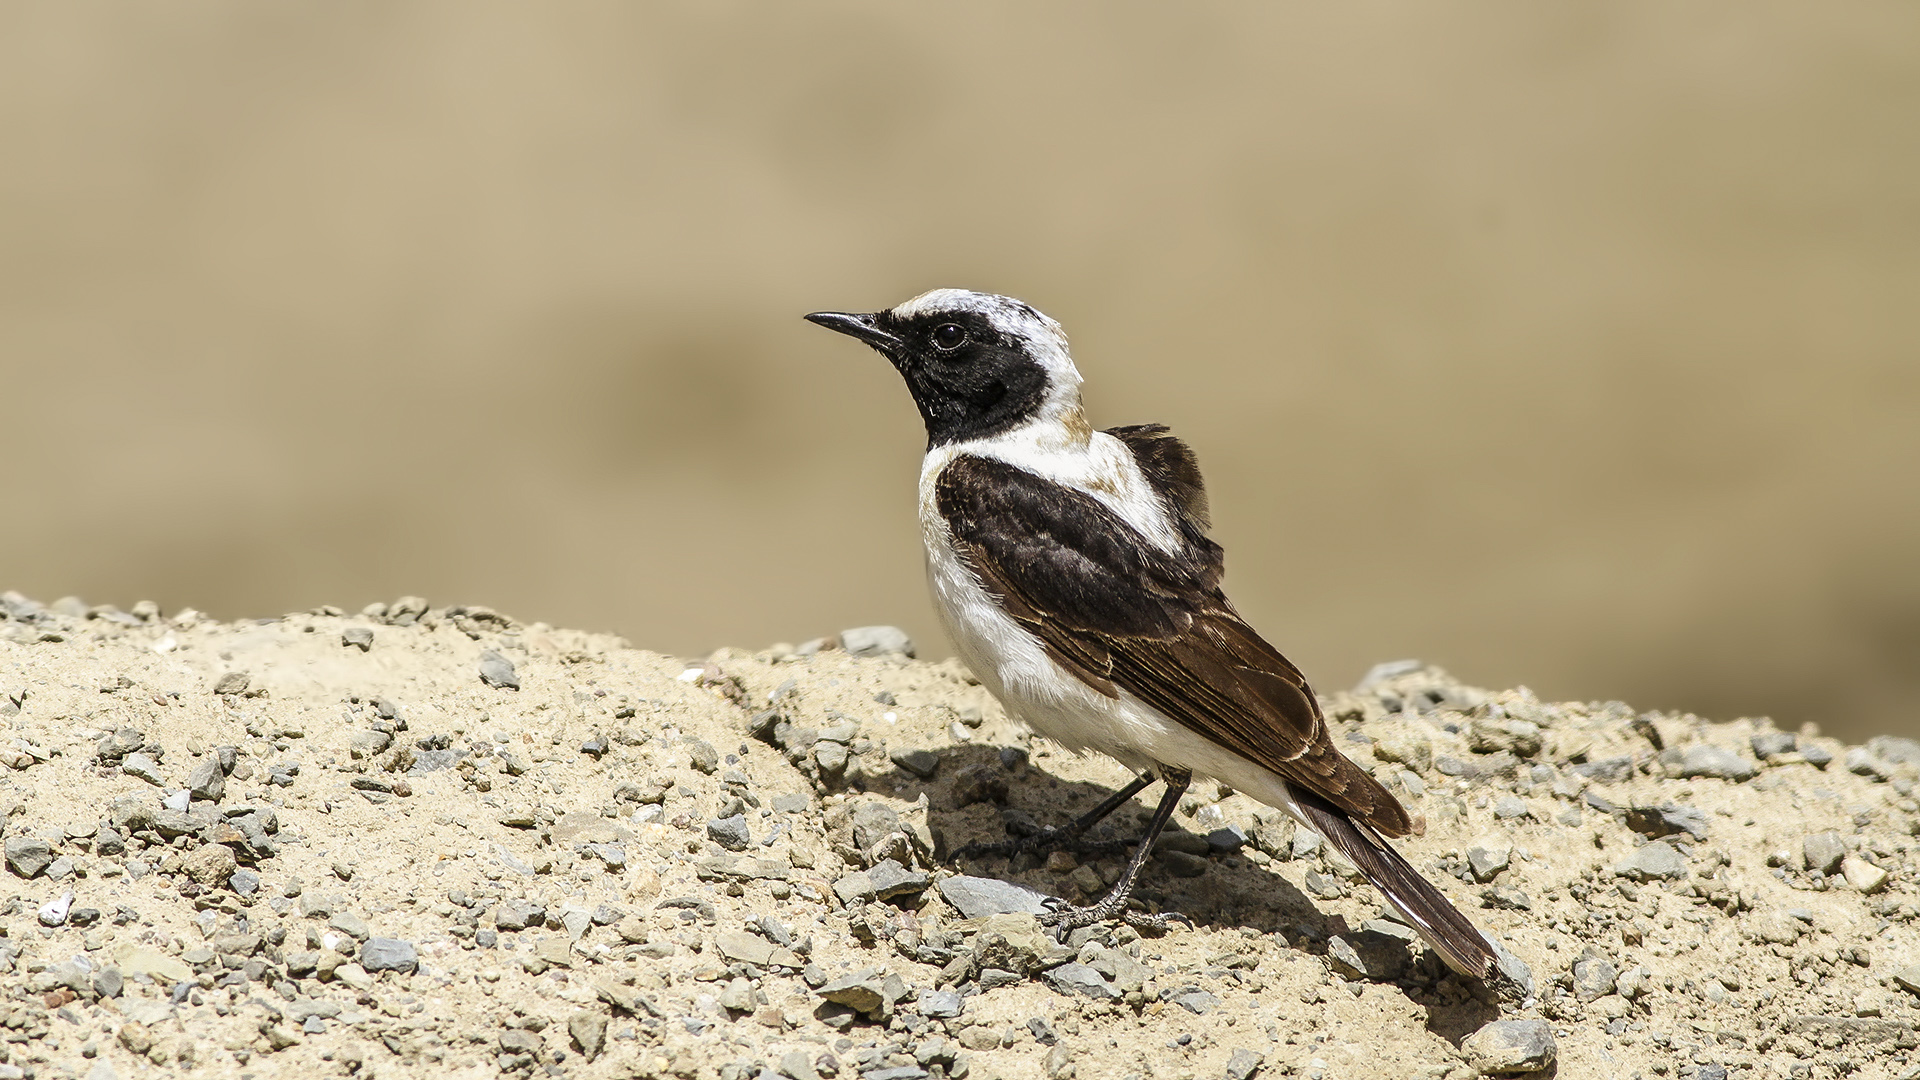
top-left (806, 288), bottom-right (1496, 978)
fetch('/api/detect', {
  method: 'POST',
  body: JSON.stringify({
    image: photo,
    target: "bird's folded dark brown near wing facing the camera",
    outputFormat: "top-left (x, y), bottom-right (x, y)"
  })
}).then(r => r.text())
top-left (935, 447), bottom-right (1413, 836)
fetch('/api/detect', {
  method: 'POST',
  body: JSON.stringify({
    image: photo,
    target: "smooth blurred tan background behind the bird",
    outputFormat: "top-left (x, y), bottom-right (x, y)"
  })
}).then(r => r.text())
top-left (0, 0), bottom-right (1920, 736)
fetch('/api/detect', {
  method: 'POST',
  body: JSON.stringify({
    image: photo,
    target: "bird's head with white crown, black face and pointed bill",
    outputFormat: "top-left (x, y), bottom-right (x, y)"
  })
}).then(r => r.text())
top-left (806, 288), bottom-right (1087, 448)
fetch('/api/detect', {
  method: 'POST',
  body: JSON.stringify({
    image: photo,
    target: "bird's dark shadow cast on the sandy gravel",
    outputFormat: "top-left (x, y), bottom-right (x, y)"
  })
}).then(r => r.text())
top-left (856, 744), bottom-right (1500, 1014)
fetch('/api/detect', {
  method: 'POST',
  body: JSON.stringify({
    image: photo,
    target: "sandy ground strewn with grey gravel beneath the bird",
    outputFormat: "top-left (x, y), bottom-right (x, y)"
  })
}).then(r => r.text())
top-left (0, 594), bottom-right (1920, 1080)
